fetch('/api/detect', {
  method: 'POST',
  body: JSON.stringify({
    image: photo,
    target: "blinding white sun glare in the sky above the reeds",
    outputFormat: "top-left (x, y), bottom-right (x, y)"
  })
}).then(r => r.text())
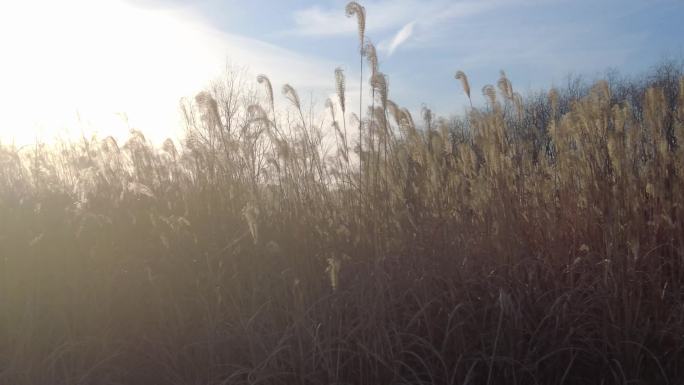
top-left (0, 0), bottom-right (222, 144)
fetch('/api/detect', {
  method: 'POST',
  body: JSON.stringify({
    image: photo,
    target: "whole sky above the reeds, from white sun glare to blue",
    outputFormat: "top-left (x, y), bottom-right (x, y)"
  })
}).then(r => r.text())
top-left (0, 0), bottom-right (684, 144)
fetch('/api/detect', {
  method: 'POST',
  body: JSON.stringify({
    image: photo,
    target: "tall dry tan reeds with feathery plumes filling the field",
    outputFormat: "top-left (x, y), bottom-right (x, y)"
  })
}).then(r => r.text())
top-left (0, 3), bottom-right (684, 385)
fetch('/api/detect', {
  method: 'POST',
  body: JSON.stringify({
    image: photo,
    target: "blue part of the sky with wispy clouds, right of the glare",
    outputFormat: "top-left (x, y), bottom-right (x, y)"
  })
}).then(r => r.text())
top-left (130, 0), bottom-right (684, 114)
